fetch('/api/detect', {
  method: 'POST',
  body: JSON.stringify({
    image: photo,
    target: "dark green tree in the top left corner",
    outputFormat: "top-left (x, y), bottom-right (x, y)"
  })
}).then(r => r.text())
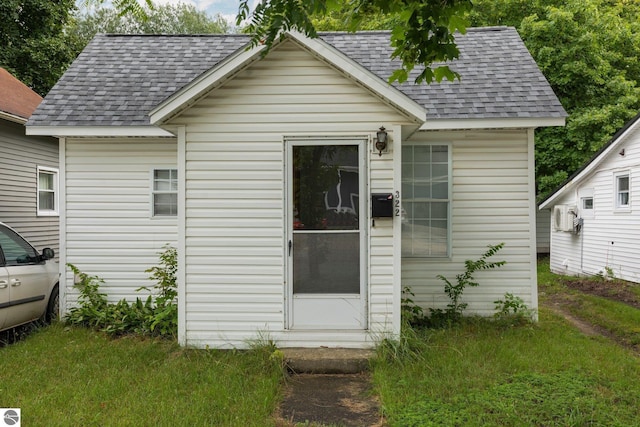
top-left (0, 0), bottom-right (80, 96)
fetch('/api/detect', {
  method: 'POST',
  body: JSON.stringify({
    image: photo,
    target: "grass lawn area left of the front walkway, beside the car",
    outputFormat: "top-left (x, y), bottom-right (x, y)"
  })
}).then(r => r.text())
top-left (0, 324), bottom-right (282, 426)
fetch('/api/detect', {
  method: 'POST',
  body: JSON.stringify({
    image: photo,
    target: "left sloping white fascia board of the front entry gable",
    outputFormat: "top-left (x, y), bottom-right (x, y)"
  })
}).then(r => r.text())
top-left (149, 45), bottom-right (266, 125)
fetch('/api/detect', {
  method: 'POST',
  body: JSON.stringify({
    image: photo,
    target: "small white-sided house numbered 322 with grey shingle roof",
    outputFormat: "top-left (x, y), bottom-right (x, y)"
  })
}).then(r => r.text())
top-left (28, 27), bottom-right (565, 347)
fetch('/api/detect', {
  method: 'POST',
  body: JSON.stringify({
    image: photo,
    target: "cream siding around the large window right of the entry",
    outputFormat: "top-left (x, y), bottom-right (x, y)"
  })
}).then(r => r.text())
top-left (402, 130), bottom-right (537, 315)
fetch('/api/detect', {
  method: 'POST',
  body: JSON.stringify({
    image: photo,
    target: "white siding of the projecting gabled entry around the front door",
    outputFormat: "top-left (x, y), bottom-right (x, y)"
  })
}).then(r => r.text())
top-left (171, 42), bottom-right (406, 347)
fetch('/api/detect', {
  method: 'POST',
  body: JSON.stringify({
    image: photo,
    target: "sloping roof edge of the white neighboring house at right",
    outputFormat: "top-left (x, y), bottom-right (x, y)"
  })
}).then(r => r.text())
top-left (538, 113), bottom-right (640, 209)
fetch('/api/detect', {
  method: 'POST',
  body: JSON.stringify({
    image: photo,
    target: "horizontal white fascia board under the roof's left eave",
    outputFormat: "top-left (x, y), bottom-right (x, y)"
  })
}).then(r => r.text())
top-left (26, 126), bottom-right (175, 138)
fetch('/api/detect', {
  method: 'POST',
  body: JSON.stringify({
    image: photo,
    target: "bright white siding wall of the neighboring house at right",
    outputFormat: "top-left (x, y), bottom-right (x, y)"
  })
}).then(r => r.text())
top-left (551, 124), bottom-right (640, 282)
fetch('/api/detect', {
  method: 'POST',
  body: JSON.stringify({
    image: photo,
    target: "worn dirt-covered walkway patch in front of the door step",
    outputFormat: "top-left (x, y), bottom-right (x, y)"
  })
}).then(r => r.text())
top-left (276, 373), bottom-right (384, 427)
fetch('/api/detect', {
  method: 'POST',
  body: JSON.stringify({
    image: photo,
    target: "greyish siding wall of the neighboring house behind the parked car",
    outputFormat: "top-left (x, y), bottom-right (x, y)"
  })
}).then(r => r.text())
top-left (0, 120), bottom-right (59, 252)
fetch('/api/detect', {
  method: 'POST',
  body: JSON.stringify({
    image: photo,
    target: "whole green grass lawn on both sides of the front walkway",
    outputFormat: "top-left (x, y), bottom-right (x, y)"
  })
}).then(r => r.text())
top-left (0, 265), bottom-right (640, 427)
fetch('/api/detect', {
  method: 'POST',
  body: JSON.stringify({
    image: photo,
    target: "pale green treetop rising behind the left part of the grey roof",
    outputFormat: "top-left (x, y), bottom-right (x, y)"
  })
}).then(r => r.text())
top-left (74, 3), bottom-right (230, 44)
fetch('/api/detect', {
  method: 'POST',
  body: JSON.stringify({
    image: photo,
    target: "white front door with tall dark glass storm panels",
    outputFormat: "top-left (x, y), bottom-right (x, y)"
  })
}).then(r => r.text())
top-left (287, 139), bottom-right (367, 330)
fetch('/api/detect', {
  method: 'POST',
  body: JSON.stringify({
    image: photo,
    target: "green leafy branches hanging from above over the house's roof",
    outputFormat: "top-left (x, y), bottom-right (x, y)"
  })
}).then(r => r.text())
top-left (236, 0), bottom-right (471, 83)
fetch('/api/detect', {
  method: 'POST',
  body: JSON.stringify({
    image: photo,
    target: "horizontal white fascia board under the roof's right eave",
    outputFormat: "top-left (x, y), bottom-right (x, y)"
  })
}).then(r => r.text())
top-left (420, 117), bottom-right (565, 130)
